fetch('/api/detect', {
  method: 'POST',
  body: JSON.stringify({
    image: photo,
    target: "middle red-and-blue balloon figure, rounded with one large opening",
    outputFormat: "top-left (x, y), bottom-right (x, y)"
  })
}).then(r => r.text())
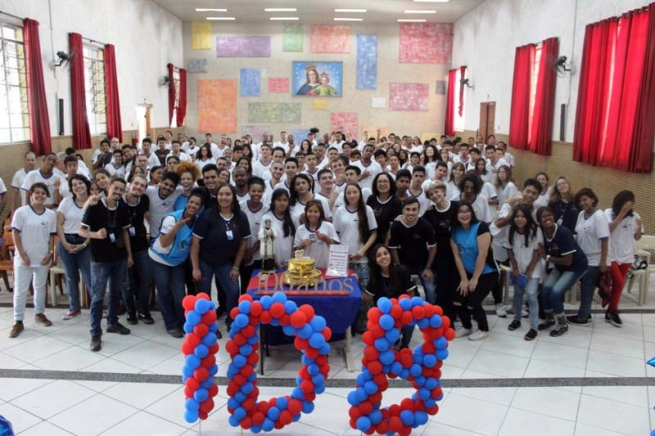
top-left (225, 292), bottom-right (332, 433)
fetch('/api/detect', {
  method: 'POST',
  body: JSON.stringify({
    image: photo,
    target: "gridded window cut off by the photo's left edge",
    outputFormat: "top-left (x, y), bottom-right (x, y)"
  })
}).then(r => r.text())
top-left (0, 21), bottom-right (30, 144)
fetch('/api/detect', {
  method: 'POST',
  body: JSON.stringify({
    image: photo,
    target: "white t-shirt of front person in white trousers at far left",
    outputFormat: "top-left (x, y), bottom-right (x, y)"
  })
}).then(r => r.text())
top-left (11, 206), bottom-right (56, 268)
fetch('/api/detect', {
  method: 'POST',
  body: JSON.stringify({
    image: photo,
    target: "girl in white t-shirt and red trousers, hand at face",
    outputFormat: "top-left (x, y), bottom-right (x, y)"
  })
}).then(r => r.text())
top-left (603, 191), bottom-right (643, 327)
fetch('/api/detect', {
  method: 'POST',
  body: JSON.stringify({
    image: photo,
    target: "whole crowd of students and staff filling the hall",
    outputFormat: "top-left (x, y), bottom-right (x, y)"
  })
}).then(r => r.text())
top-left (5, 128), bottom-right (642, 351)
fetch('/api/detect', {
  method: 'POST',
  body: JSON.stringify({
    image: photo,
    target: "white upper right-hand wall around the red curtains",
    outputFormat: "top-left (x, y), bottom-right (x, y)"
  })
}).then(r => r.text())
top-left (453, 0), bottom-right (653, 142)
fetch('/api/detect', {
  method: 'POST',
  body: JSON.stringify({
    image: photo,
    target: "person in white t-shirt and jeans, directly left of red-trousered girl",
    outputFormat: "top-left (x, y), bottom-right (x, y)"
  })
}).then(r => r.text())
top-left (566, 188), bottom-right (610, 325)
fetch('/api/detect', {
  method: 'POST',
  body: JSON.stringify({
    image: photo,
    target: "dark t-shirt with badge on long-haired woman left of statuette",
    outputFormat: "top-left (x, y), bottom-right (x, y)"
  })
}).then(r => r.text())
top-left (193, 208), bottom-right (250, 267)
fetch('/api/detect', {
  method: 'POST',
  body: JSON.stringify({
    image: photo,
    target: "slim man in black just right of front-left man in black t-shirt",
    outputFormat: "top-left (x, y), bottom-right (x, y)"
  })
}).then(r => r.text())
top-left (121, 175), bottom-right (155, 325)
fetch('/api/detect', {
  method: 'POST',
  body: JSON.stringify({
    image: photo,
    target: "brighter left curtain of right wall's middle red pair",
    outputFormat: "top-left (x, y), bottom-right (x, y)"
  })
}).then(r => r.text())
top-left (509, 44), bottom-right (535, 150)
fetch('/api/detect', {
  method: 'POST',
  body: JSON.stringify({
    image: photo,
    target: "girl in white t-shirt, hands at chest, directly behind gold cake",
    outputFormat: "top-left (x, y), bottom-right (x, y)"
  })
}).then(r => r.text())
top-left (293, 200), bottom-right (339, 269)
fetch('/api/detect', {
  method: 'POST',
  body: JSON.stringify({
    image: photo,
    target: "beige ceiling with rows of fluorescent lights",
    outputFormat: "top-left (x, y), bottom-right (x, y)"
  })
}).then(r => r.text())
top-left (154, 0), bottom-right (484, 24)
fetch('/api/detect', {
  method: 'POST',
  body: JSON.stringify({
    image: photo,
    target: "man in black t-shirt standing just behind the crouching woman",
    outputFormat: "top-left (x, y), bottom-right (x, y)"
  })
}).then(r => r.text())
top-left (389, 197), bottom-right (437, 304)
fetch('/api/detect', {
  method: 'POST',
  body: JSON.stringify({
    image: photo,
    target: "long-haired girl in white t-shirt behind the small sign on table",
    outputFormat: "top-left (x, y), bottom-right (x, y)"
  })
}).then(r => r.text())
top-left (333, 183), bottom-right (378, 289)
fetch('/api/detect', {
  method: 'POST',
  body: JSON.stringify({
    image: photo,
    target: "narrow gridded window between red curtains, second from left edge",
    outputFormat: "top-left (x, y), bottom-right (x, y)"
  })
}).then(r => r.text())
top-left (84, 44), bottom-right (107, 136)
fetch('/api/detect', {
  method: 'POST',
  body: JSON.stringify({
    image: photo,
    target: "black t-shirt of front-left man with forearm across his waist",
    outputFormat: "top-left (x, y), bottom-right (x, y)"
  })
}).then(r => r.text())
top-left (82, 199), bottom-right (130, 262)
